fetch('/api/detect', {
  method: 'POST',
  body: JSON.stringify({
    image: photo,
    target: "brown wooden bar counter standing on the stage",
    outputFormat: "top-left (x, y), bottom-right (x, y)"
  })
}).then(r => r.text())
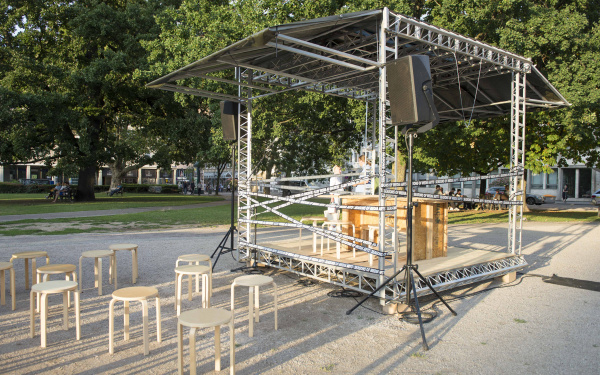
top-left (340, 195), bottom-right (448, 261)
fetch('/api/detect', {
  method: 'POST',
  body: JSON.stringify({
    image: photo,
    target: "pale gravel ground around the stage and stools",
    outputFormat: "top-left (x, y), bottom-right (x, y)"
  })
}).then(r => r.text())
top-left (0, 223), bottom-right (600, 374)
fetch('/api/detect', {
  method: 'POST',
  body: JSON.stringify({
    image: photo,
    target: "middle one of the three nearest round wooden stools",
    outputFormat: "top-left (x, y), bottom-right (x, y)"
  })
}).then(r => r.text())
top-left (108, 286), bottom-right (162, 355)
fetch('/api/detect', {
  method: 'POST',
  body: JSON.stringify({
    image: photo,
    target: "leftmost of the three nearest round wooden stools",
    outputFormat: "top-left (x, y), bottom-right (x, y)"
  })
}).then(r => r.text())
top-left (29, 280), bottom-right (81, 348)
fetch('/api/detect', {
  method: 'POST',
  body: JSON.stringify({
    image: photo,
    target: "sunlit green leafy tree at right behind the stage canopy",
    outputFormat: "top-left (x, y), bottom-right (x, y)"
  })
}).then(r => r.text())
top-left (415, 0), bottom-right (600, 180)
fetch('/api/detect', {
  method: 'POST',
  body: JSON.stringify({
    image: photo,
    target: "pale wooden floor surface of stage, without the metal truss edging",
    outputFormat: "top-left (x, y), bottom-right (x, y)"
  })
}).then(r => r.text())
top-left (259, 232), bottom-right (513, 276)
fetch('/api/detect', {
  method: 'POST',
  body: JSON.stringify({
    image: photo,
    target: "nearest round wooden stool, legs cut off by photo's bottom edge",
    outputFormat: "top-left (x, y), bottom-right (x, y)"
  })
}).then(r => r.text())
top-left (177, 307), bottom-right (235, 375)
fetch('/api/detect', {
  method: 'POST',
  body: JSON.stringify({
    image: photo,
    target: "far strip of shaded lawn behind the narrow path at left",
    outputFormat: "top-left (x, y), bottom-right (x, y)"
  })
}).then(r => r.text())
top-left (0, 193), bottom-right (224, 215)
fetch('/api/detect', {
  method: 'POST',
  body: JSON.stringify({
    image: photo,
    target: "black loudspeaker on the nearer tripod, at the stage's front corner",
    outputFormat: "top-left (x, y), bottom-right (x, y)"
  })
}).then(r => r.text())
top-left (387, 55), bottom-right (439, 133)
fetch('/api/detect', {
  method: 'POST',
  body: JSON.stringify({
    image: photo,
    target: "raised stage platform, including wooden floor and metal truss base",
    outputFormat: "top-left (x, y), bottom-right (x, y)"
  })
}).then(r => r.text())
top-left (250, 230), bottom-right (527, 300)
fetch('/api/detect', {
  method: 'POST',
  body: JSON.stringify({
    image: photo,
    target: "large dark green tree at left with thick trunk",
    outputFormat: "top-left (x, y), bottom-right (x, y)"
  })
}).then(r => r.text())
top-left (0, 0), bottom-right (207, 200)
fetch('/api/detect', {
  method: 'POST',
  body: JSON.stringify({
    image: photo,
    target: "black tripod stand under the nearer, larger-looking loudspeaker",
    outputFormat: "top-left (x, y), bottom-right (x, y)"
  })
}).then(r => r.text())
top-left (346, 131), bottom-right (456, 350)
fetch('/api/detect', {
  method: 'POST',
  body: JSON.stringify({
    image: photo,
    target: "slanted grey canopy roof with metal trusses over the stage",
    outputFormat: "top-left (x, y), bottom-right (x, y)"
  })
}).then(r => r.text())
top-left (147, 9), bottom-right (569, 121)
